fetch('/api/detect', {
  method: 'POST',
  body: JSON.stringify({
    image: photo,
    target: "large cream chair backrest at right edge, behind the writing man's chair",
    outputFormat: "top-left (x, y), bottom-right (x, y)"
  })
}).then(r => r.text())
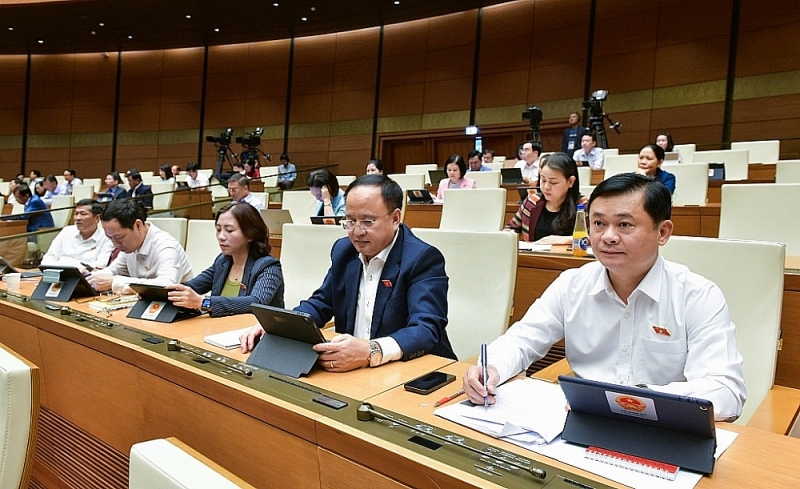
top-left (719, 183), bottom-right (800, 255)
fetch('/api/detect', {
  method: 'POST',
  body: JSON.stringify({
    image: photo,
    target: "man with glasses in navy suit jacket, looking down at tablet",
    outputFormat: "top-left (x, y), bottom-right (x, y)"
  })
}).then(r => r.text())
top-left (242, 174), bottom-right (456, 372)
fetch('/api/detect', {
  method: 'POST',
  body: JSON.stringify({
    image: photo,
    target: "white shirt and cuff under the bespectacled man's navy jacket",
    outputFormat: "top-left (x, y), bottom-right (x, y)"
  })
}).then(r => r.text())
top-left (353, 231), bottom-right (403, 365)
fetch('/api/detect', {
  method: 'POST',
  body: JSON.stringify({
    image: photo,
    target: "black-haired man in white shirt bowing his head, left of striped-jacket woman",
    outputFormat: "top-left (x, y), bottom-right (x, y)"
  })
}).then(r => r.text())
top-left (87, 199), bottom-right (194, 293)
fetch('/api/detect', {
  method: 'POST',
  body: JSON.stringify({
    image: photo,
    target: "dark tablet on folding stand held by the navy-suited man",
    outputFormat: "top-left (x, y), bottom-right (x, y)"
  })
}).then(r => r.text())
top-left (247, 304), bottom-right (327, 378)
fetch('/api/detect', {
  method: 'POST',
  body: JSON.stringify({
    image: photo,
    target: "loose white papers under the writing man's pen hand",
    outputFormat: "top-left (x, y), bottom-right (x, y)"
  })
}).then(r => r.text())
top-left (434, 379), bottom-right (567, 445)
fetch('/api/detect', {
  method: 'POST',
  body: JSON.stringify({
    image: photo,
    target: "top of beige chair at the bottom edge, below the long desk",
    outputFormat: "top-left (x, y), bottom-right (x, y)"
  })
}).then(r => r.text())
top-left (128, 438), bottom-right (253, 489)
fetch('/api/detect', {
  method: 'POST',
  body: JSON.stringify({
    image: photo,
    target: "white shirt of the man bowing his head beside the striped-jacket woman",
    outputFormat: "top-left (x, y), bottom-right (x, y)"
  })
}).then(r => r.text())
top-left (98, 222), bottom-right (194, 290)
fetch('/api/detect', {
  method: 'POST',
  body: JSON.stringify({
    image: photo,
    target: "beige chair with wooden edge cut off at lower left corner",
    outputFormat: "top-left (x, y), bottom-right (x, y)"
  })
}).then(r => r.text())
top-left (0, 343), bottom-right (39, 489)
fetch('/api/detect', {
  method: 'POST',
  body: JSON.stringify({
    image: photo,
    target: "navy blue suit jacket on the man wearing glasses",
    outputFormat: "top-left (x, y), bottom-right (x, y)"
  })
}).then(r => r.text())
top-left (295, 224), bottom-right (456, 360)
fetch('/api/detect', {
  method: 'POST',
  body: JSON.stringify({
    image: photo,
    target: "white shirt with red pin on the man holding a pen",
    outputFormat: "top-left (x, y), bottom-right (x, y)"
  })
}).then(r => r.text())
top-left (488, 257), bottom-right (746, 420)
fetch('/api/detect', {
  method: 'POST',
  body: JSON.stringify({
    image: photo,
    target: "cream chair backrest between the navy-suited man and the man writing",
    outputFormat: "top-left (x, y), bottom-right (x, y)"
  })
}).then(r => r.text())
top-left (414, 228), bottom-right (518, 359)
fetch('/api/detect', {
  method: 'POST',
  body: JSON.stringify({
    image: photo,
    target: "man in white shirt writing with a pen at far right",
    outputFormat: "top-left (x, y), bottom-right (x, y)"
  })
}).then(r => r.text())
top-left (464, 173), bottom-right (746, 421)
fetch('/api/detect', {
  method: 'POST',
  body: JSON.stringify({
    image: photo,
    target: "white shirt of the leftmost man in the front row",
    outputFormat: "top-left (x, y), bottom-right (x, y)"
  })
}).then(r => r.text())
top-left (42, 224), bottom-right (114, 269)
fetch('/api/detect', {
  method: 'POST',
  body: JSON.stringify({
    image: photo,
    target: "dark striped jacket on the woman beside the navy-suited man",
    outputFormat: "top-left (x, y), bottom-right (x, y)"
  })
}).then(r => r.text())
top-left (184, 254), bottom-right (284, 317)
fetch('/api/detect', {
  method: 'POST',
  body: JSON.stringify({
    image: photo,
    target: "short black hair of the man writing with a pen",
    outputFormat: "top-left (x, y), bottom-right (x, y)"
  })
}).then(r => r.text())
top-left (587, 172), bottom-right (672, 226)
